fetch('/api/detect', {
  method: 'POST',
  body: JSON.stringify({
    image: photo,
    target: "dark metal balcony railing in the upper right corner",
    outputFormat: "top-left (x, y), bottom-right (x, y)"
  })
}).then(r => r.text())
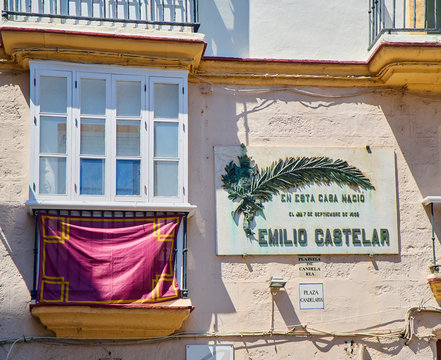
top-left (369, 0), bottom-right (441, 48)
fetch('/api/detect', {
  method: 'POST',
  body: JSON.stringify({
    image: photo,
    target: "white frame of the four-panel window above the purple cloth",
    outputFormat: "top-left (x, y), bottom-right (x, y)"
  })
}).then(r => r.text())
top-left (28, 60), bottom-right (189, 210)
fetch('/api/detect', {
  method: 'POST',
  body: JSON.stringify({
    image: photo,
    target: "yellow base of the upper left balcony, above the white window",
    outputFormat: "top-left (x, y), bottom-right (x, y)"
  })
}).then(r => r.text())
top-left (0, 26), bottom-right (205, 70)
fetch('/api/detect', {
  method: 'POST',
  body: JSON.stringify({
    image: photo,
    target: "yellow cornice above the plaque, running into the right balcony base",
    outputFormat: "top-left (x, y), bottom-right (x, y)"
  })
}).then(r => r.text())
top-left (189, 42), bottom-right (441, 92)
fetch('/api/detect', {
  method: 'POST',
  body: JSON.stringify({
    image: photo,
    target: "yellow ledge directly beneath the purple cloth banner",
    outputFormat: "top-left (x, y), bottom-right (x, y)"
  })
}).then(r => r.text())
top-left (31, 300), bottom-right (193, 339)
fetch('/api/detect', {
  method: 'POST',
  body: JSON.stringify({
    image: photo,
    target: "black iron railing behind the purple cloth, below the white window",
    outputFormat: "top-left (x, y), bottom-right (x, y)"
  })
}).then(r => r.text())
top-left (31, 210), bottom-right (188, 300)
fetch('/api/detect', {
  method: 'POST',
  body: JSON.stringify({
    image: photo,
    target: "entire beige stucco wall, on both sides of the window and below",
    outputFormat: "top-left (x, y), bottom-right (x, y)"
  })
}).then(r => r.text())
top-left (0, 73), bottom-right (441, 360)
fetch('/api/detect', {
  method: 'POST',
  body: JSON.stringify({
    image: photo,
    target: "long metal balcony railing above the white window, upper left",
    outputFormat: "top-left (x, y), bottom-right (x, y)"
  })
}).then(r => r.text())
top-left (2, 0), bottom-right (199, 32)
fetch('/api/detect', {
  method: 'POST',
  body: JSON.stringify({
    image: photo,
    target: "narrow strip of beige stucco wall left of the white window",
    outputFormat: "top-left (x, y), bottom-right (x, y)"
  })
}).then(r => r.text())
top-left (0, 71), bottom-right (39, 337)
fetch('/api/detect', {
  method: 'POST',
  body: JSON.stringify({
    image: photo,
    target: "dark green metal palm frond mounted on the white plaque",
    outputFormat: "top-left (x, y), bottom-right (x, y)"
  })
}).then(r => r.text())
top-left (221, 146), bottom-right (375, 237)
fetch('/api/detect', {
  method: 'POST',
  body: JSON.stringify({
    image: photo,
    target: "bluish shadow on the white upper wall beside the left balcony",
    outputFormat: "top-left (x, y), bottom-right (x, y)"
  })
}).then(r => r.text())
top-left (199, 0), bottom-right (250, 57)
